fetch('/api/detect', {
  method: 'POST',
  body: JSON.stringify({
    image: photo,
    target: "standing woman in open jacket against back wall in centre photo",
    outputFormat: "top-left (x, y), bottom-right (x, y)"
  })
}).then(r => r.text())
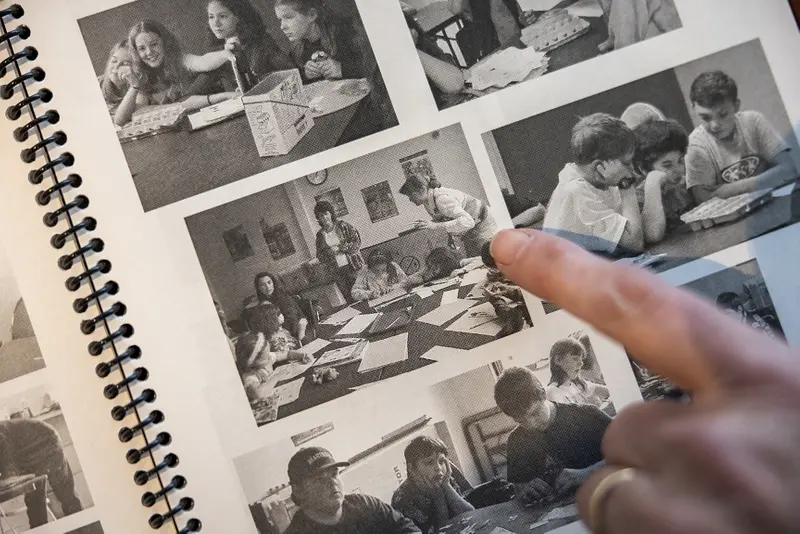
top-left (314, 200), bottom-right (364, 299)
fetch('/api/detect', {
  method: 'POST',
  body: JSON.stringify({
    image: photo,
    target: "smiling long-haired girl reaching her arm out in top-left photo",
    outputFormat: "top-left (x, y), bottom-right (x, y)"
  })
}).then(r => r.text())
top-left (114, 20), bottom-right (235, 126)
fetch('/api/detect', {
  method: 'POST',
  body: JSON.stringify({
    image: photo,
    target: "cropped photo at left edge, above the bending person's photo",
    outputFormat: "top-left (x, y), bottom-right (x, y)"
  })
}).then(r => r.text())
top-left (0, 245), bottom-right (45, 383)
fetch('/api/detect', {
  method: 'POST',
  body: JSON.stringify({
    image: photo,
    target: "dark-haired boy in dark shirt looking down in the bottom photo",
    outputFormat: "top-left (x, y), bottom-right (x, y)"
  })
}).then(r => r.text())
top-left (494, 367), bottom-right (611, 502)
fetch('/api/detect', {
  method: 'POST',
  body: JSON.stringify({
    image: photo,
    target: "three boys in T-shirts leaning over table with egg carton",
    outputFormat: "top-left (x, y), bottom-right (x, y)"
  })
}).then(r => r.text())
top-left (543, 71), bottom-right (797, 256)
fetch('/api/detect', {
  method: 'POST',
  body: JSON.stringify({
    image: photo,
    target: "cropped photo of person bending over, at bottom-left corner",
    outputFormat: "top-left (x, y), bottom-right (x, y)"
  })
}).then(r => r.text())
top-left (0, 386), bottom-right (94, 532)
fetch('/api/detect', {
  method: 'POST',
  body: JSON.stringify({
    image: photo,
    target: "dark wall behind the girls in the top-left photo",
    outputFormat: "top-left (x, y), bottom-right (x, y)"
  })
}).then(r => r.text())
top-left (78, 0), bottom-right (358, 75)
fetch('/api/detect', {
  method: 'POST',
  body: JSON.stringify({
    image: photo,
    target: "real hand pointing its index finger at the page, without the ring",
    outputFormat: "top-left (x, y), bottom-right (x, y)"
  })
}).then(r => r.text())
top-left (492, 230), bottom-right (800, 534)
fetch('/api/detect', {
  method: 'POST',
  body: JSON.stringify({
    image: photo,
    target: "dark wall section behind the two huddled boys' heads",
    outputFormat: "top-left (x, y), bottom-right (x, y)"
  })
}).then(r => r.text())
top-left (493, 70), bottom-right (693, 205)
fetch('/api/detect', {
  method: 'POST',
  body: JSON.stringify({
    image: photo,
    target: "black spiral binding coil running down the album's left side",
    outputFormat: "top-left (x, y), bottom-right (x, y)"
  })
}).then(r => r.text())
top-left (0, 4), bottom-right (202, 534)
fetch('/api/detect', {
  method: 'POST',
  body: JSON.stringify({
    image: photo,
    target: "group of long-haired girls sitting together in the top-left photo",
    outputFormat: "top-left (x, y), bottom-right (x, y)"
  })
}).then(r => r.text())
top-left (100, 0), bottom-right (369, 126)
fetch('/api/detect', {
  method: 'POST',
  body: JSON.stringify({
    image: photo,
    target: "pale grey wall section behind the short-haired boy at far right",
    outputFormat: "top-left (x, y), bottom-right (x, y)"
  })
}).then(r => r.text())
top-left (675, 40), bottom-right (800, 165)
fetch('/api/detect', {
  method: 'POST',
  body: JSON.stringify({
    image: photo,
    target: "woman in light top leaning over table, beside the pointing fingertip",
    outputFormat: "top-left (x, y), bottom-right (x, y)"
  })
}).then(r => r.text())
top-left (400, 175), bottom-right (498, 257)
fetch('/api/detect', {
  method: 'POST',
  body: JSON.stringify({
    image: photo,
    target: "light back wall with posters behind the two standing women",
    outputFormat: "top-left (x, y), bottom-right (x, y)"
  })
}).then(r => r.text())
top-left (286, 125), bottom-right (486, 251)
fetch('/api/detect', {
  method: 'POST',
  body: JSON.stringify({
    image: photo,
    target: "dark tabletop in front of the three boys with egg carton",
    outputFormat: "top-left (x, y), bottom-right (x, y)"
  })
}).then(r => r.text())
top-left (647, 186), bottom-right (800, 272)
